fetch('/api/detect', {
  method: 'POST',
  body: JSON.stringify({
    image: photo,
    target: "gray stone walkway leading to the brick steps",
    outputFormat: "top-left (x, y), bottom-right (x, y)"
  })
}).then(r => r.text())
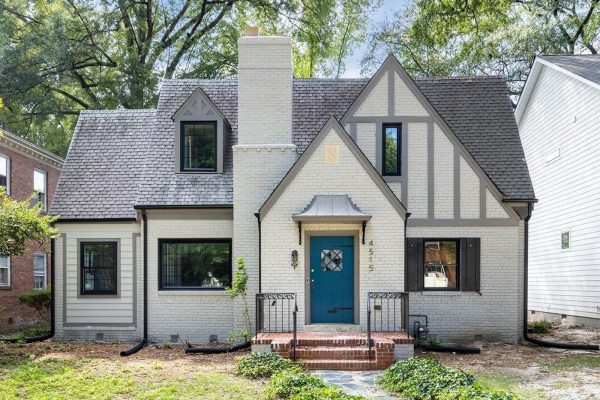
top-left (311, 370), bottom-right (396, 400)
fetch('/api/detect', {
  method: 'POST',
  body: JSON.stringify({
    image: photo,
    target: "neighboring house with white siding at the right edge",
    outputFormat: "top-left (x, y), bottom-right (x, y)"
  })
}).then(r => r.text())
top-left (515, 55), bottom-right (600, 326)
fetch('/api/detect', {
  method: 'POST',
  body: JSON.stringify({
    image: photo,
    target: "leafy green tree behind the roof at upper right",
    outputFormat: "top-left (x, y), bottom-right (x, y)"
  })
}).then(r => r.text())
top-left (363, 0), bottom-right (600, 95)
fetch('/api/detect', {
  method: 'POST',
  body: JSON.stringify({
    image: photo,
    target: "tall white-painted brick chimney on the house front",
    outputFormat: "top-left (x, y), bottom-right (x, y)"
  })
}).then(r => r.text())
top-left (233, 28), bottom-right (297, 338)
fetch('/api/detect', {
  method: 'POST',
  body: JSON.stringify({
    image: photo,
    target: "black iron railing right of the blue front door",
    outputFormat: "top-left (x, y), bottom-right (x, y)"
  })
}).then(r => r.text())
top-left (367, 292), bottom-right (408, 358)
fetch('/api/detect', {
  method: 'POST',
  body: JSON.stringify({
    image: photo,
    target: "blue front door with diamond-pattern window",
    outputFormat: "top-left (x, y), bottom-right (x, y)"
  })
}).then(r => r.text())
top-left (310, 236), bottom-right (354, 324)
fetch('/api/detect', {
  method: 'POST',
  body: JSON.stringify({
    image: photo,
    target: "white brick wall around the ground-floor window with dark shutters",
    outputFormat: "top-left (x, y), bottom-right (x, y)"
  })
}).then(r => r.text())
top-left (407, 223), bottom-right (523, 342)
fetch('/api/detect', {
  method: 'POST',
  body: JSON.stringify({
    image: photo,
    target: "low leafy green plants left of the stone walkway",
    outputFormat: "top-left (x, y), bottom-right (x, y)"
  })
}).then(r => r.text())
top-left (236, 353), bottom-right (362, 400)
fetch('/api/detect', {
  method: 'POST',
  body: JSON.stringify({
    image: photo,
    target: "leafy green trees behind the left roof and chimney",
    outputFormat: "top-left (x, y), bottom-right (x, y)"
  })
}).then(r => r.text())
top-left (0, 0), bottom-right (379, 156)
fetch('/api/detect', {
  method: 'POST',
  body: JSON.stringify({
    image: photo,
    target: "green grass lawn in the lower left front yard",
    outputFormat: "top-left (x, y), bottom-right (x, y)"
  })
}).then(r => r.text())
top-left (0, 358), bottom-right (262, 400)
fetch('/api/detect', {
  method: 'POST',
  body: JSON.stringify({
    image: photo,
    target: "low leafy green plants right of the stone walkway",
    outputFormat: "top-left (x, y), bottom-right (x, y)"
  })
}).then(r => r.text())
top-left (378, 357), bottom-right (518, 400)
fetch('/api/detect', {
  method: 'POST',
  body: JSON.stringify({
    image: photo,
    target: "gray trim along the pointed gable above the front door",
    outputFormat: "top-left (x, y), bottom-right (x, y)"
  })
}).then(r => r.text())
top-left (258, 116), bottom-right (407, 219)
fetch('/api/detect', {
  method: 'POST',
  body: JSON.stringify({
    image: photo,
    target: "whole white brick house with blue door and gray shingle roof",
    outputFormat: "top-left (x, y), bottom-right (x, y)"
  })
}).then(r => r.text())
top-left (51, 31), bottom-right (534, 343)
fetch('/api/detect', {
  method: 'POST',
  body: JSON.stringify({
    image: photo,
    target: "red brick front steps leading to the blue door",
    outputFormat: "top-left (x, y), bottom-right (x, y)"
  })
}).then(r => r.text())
top-left (252, 332), bottom-right (413, 371)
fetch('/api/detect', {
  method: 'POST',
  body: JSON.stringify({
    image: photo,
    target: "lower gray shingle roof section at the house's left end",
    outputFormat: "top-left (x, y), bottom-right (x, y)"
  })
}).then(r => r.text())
top-left (50, 110), bottom-right (155, 219)
